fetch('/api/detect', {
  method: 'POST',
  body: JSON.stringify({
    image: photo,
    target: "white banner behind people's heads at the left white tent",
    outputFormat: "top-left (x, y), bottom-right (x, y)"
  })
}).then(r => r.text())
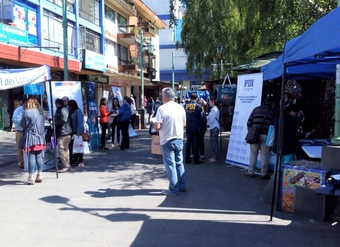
top-left (46, 81), bottom-right (83, 117)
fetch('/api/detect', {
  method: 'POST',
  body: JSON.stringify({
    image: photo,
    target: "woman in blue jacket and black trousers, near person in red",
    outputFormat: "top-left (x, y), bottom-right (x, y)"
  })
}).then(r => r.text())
top-left (118, 96), bottom-right (132, 150)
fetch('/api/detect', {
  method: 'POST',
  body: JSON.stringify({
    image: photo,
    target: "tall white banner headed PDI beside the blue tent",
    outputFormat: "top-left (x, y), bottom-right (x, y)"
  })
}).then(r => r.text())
top-left (225, 73), bottom-right (263, 167)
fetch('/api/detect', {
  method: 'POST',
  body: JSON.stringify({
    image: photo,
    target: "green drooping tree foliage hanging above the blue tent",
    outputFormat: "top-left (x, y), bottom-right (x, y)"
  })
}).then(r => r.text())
top-left (170, 0), bottom-right (337, 78)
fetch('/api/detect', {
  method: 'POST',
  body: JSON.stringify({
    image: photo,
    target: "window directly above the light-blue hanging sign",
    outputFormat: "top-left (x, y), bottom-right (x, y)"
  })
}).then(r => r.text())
top-left (79, 27), bottom-right (100, 53)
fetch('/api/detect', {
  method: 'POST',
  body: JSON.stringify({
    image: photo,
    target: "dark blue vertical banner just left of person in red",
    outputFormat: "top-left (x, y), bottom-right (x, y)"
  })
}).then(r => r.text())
top-left (86, 82), bottom-right (100, 151)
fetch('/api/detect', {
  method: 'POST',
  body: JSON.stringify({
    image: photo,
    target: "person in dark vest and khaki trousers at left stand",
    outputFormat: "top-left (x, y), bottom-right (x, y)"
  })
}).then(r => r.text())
top-left (54, 98), bottom-right (72, 173)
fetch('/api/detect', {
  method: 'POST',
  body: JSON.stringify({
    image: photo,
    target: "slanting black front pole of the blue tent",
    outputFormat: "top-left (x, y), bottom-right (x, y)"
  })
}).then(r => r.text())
top-left (270, 64), bottom-right (288, 221)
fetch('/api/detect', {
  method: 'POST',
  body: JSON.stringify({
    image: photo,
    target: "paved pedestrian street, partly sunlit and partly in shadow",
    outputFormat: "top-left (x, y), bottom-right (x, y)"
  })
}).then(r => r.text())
top-left (0, 130), bottom-right (340, 247)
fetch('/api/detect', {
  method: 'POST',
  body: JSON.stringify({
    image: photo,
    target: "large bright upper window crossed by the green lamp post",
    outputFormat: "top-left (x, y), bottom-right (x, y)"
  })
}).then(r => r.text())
top-left (42, 10), bottom-right (76, 55)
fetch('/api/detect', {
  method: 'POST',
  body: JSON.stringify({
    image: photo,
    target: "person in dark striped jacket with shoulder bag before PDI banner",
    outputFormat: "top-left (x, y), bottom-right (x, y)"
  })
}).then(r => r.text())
top-left (244, 98), bottom-right (276, 179)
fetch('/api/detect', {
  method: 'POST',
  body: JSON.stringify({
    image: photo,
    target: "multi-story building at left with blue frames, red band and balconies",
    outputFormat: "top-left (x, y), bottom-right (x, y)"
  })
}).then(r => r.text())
top-left (0, 0), bottom-right (166, 128)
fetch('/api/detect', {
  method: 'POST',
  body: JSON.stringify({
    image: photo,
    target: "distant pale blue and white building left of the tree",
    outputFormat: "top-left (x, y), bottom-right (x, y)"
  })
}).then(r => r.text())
top-left (139, 0), bottom-right (207, 96)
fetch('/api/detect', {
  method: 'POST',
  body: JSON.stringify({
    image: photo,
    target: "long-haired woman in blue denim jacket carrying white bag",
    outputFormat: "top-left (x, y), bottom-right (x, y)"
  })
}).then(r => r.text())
top-left (68, 100), bottom-right (85, 166)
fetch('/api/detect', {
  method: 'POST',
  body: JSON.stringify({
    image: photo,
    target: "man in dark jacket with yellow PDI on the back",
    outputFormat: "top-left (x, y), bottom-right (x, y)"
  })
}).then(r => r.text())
top-left (184, 93), bottom-right (204, 165)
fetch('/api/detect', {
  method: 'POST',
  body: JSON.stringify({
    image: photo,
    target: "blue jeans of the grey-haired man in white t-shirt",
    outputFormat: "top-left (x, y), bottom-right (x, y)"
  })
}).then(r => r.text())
top-left (161, 139), bottom-right (186, 194)
